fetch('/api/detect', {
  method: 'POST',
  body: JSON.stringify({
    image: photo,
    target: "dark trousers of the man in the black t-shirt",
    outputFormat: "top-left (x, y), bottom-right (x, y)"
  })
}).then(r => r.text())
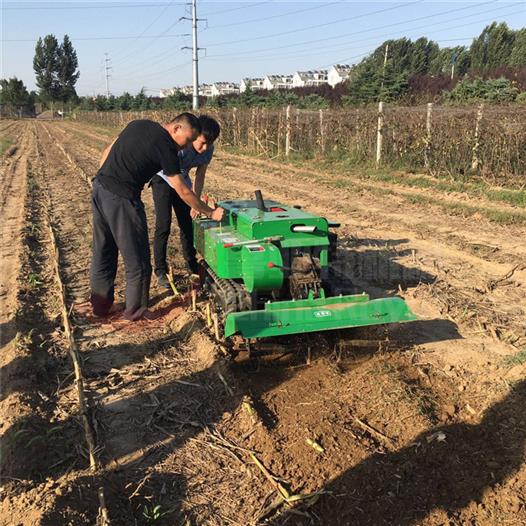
top-left (90, 179), bottom-right (152, 320)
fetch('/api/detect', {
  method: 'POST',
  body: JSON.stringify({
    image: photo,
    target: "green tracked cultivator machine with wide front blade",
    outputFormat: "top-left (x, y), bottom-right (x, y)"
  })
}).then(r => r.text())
top-left (194, 191), bottom-right (416, 339)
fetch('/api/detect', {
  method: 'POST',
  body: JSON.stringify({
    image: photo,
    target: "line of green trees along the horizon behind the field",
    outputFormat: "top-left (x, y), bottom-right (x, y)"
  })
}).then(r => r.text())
top-left (0, 22), bottom-right (526, 116)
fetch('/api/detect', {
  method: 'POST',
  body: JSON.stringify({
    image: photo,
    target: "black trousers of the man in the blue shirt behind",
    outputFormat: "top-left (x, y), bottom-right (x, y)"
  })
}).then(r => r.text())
top-left (151, 175), bottom-right (198, 274)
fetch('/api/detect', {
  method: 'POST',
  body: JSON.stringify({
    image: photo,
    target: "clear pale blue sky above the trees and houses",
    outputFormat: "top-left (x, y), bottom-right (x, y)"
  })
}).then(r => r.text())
top-left (0, 0), bottom-right (526, 95)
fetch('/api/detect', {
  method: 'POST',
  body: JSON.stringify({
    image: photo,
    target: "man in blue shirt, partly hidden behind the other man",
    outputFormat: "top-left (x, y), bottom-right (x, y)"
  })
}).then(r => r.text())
top-left (152, 115), bottom-right (221, 289)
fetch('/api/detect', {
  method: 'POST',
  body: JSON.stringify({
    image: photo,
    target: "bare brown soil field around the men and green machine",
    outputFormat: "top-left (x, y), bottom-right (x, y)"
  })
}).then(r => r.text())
top-left (0, 120), bottom-right (526, 526)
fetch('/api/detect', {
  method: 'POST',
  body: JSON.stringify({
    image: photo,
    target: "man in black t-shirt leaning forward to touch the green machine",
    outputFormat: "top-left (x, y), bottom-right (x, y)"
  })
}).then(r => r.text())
top-left (90, 113), bottom-right (223, 320)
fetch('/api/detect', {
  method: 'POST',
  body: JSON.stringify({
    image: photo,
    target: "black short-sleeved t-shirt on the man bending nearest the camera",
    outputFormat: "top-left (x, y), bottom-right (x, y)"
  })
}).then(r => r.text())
top-left (97, 120), bottom-right (181, 199)
